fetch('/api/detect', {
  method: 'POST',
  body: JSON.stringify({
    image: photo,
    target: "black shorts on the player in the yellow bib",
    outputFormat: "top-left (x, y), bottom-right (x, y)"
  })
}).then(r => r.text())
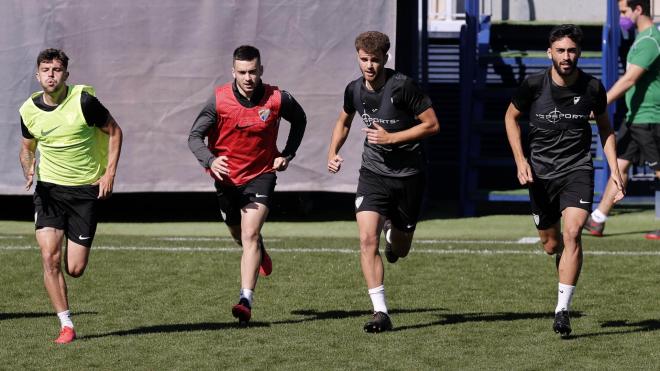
top-left (34, 181), bottom-right (99, 247)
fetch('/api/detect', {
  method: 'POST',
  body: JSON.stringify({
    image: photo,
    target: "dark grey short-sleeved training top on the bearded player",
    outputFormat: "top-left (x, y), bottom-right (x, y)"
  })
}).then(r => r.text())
top-left (512, 69), bottom-right (607, 179)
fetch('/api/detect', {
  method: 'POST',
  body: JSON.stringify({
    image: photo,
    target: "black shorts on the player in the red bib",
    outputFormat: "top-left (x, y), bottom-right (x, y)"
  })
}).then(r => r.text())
top-left (215, 173), bottom-right (277, 226)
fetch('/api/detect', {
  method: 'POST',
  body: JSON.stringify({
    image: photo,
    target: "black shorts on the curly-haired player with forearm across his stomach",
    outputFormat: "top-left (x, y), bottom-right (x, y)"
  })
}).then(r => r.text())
top-left (355, 168), bottom-right (426, 232)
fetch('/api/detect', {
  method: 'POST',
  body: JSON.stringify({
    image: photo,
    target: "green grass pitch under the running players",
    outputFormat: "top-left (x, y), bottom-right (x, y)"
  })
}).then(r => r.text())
top-left (0, 211), bottom-right (660, 370)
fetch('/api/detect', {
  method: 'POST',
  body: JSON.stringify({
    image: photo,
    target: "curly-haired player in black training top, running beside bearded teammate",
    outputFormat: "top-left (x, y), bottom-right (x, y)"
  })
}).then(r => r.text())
top-left (328, 31), bottom-right (440, 332)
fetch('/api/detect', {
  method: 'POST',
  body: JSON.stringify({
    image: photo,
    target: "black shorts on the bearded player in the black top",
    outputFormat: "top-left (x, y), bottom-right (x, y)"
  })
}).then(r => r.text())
top-left (529, 170), bottom-right (594, 230)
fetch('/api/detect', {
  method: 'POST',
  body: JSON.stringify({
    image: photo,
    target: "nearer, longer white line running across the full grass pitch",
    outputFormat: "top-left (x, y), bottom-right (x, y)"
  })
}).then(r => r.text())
top-left (0, 246), bottom-right (660, 256)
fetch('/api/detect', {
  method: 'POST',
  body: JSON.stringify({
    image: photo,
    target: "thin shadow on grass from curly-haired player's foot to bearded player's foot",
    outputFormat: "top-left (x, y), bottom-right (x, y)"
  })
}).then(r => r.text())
top-left (392, 312), bottom-right (582, 331)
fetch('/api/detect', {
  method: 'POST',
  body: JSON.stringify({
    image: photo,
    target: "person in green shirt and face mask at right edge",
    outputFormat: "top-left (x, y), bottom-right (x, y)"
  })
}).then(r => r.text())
top-left (584, 0), bottom-right (660, 240)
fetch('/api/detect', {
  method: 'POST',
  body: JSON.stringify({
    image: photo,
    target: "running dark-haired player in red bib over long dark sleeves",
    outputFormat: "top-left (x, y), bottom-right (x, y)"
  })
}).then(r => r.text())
top-left (188, 45), bottom-right (307, 324)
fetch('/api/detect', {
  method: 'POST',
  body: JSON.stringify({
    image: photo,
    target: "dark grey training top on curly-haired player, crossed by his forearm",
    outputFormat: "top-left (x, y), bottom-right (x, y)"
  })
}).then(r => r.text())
top-left (344, 69), bottom-right (432, 177)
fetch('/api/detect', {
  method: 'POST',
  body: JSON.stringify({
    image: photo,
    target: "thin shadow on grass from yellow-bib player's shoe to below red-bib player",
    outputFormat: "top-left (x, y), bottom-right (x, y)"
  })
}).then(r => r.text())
top-left (77, 321), bottom-right (270, 339)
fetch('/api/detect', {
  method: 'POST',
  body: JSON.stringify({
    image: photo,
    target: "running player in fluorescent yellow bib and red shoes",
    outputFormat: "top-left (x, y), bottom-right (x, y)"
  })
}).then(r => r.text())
top-left (19, 49), bottom-right (122, 344)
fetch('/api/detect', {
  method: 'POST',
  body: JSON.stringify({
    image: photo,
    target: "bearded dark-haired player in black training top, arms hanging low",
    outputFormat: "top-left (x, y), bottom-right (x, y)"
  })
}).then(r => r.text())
top-left (505, 25), bottom-right (623, 337)
